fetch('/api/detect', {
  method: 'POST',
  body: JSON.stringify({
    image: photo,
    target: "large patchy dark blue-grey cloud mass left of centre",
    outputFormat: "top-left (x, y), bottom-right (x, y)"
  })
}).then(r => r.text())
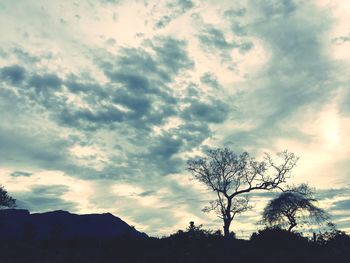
top-left (0, 38), bottom-right (193, 144)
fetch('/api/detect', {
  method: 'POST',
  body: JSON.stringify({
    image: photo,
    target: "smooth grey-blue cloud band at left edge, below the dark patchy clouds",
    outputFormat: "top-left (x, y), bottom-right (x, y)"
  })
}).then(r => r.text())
top-left (0, 124), bottom-right (97, 178)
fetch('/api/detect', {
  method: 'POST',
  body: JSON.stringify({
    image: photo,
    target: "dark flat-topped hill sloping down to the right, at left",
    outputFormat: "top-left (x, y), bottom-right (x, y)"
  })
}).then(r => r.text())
top-left (0, 209), bottom-right (147, 240)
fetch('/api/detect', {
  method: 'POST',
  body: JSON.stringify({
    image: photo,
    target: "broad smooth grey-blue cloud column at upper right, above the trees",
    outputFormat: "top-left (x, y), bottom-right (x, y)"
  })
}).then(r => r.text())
top-left (226, 1), bottom-right (336, 151)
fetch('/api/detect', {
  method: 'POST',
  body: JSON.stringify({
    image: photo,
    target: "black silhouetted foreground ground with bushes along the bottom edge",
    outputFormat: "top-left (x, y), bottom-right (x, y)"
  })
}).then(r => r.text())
top-left (0, 229), bottom-right (350, 263)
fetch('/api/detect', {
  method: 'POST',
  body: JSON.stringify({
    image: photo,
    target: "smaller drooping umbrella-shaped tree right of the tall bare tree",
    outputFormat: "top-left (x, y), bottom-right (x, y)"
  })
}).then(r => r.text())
top-left (263, 184), bottom-right (329, 231)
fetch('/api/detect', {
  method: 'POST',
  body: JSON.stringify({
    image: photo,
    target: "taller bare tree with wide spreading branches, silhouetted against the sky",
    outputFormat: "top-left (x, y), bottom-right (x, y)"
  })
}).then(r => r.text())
top-left (187, 148), bottom-right (298, 237)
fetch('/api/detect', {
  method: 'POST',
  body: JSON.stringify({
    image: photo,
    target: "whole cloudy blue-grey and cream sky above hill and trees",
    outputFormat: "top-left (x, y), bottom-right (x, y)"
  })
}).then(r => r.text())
top-left (0, 0), bottom-right (350, 236)
